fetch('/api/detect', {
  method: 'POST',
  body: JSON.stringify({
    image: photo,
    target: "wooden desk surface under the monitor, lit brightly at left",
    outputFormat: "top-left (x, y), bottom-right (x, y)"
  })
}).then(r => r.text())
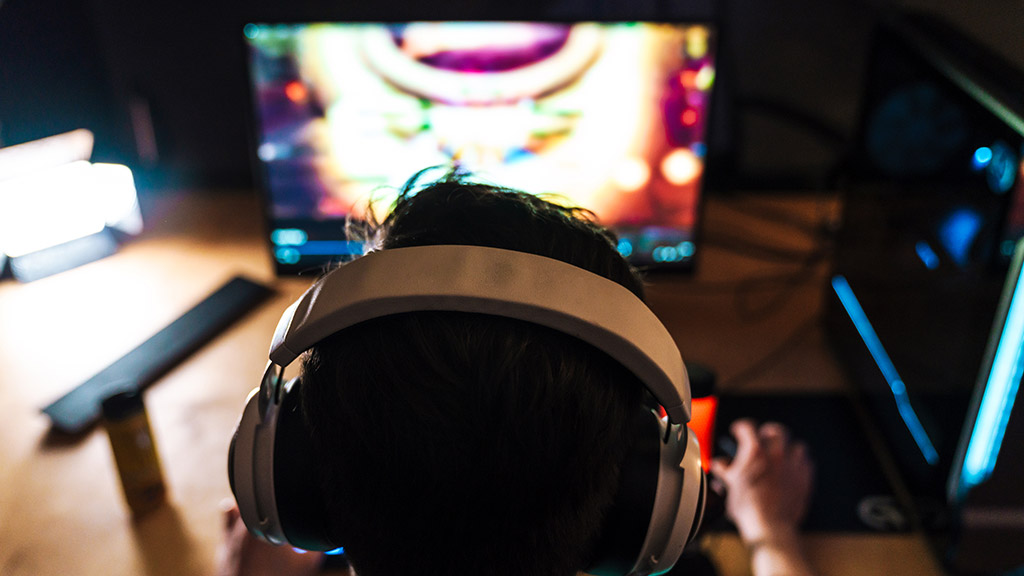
top-left (0, 186), bottom-right (941, 576)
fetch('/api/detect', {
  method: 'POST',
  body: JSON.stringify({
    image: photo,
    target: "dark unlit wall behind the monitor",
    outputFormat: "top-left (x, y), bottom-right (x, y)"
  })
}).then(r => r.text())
top-left (0, 0), bottom-right (1024, 189)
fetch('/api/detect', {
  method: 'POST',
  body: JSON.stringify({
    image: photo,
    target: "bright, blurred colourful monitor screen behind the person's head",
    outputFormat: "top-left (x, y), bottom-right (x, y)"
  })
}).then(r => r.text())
top-left (245, 22), bottom-right (715, 274)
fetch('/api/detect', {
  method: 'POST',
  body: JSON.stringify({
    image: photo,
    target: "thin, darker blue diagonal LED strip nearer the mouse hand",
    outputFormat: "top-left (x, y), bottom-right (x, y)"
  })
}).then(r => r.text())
top-left (833, 276), bottom-right (939, 466)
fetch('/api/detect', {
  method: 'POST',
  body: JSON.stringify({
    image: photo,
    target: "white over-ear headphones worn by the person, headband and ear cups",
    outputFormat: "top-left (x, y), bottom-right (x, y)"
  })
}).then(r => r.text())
top-left (228, 246), bottom-right (706, 576)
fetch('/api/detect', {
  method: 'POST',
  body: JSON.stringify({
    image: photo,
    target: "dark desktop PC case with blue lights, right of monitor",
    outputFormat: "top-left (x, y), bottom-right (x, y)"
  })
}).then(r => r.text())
top-left (825, 10), bottom-right (1024, 574)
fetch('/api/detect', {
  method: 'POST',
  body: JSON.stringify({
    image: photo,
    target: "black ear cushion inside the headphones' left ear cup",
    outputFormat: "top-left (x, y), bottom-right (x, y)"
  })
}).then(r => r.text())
top-left (273, 379), bottom-right (340, 550)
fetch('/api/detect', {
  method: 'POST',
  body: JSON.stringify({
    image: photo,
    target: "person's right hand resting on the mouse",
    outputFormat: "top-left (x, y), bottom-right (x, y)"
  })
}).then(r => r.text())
top-left (711, 419), bottom-right (814, 546)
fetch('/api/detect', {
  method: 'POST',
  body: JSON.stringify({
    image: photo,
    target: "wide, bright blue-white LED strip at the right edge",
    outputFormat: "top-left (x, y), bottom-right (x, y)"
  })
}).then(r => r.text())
top-left (961, 264), bottom-right (1024, 489)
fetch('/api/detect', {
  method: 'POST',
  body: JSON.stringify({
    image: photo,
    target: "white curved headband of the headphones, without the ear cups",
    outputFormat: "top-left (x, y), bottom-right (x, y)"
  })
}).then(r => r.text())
top-left (264, 245), bottom-right (690, 423)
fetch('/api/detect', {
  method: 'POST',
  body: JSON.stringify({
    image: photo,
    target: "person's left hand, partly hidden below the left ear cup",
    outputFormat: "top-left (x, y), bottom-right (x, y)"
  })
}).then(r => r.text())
top-left (216, 500), bottom-right (324, 576)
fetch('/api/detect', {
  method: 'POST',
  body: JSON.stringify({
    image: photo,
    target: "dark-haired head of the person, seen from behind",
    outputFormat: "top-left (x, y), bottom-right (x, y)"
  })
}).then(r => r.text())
top-left (301, 169), bottom-right (644, 576)
